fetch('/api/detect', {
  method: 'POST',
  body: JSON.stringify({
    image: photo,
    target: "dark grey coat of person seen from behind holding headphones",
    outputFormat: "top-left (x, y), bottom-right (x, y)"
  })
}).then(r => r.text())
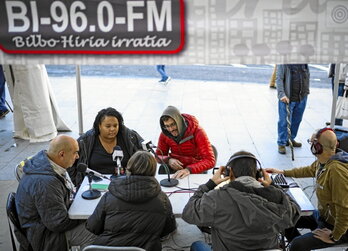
top-left (182, 180), bottom-right (301, 251)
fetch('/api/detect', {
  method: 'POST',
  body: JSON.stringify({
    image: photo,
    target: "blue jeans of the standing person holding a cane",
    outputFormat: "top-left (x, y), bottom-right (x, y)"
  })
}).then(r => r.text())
top-left (277, 96), bottom-right (307, 146)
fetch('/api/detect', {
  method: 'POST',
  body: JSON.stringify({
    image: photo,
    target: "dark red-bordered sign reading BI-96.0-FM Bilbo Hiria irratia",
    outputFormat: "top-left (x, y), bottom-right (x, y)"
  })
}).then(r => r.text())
top-left (0, 0), bottom-right (185, 54)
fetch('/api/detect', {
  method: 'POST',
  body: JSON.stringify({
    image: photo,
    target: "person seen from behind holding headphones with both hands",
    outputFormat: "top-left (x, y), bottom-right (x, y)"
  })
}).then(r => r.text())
top-left (182, 151), bottom-right (300, 251)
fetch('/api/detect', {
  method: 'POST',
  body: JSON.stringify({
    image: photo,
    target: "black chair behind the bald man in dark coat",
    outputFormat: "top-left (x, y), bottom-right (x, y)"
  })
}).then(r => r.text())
top-left (6, 192), bottom-right (33, 251)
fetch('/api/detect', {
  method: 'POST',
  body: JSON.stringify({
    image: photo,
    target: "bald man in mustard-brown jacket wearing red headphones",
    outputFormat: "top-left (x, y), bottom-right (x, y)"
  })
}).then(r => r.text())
top-left (266, 128), bottom-right (348, 251)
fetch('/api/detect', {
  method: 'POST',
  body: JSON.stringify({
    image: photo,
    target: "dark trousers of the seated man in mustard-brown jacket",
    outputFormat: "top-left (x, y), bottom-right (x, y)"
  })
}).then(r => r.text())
top-left (289, 211), bottom-right (348, 251)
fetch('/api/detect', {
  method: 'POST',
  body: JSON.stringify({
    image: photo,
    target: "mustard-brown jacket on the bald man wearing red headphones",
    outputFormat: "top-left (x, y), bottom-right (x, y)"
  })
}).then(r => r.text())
top-left (284, 150), bottom-right (348, 240)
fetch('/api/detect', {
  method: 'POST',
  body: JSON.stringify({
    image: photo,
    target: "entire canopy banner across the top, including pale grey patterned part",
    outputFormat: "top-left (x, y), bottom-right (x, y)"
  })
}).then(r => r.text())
top-left (0, 0), bottom-right (348, 64)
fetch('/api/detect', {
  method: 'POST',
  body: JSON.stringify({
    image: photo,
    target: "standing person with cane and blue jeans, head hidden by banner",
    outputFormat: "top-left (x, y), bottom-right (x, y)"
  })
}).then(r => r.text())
top-left (276, 64), bottom-right (309, 154)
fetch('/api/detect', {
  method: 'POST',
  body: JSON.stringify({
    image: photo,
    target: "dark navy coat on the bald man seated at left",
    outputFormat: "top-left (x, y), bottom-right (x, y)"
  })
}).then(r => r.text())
top-left (16, 151), bottom-right (81, 251)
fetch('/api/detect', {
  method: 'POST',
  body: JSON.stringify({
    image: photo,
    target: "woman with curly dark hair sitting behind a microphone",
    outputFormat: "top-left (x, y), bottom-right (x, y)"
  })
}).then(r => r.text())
top-left (68, 107), bottom-right (143, 186)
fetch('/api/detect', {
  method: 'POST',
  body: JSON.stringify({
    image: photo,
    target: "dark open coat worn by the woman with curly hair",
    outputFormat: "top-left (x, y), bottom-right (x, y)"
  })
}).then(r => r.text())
top-left (68, 125), bottom-right (144, 187)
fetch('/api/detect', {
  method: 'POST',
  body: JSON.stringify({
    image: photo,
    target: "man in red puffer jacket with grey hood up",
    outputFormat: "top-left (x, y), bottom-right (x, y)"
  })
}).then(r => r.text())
top-left (156, 106), bottom-right (215, 178)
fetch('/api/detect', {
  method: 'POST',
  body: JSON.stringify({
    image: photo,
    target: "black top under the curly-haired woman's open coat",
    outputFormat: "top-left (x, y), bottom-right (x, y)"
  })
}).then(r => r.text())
top-left (89, 136), bottom-right (130, 174)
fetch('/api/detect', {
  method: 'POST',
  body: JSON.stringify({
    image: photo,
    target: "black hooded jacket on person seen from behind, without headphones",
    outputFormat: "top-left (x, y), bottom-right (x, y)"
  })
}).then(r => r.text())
top-left (86, 175), bottom-right (176, 251)
